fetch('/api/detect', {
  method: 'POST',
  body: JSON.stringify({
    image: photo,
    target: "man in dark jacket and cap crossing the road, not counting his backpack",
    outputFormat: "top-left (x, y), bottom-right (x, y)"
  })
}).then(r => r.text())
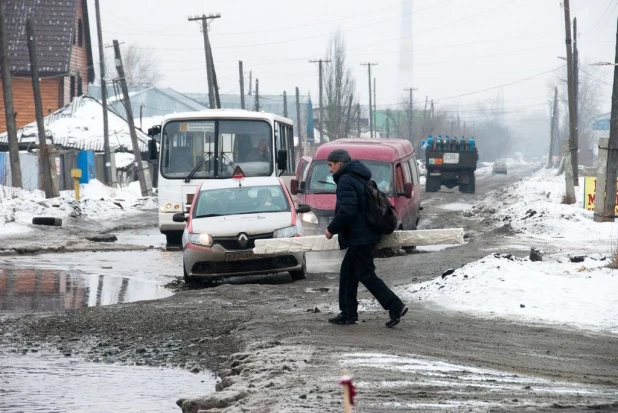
top-left (325, 149), bottom-right (408, 327)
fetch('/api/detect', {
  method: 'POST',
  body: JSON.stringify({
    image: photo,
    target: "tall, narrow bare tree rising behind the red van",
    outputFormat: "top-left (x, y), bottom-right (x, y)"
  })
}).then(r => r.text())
top-left (323, 31), bottom-right (358, 139)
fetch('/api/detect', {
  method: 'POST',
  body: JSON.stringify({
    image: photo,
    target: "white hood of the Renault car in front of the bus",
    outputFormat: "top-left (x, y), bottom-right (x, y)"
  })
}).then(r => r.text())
top-left (191, 211), bottom-right (292, 237)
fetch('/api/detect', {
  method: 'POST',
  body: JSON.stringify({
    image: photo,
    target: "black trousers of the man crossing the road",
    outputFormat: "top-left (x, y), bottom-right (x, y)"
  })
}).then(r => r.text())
top-left (339, 244), bottom-right (403, 320)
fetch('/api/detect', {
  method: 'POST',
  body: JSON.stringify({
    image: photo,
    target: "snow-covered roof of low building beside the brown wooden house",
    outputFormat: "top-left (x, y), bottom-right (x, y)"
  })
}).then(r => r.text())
top-left (0, 96), bottom-right (150, 152)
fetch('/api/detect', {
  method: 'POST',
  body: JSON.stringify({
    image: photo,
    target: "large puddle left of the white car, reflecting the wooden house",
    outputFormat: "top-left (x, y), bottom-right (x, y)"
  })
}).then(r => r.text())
top-left (0, 250), bottom-right (182, 311)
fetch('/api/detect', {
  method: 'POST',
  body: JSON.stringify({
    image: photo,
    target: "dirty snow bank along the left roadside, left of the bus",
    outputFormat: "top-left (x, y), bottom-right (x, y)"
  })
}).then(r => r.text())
top-left (0, 179), bottom-right (157, 234)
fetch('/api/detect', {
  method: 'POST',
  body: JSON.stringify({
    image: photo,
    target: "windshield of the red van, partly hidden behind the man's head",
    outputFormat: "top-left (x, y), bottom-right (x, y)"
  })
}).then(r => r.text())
top-left (306, 160), bottom-right (393, 195)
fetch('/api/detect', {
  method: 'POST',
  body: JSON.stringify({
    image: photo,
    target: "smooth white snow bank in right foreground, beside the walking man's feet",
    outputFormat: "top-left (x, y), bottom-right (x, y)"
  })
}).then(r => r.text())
top-left (397, 254), bottom-right (618, 334)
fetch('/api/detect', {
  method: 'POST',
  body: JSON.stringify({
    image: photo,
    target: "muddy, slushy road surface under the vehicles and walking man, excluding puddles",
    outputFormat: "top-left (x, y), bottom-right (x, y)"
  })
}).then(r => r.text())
top-left (0, 167), bottom-right (618, 412)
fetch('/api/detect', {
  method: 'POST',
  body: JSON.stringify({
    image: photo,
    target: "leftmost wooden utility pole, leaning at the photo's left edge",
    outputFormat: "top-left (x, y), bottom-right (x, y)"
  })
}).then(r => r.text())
top-left (0, 1), bottom-right (24, 188)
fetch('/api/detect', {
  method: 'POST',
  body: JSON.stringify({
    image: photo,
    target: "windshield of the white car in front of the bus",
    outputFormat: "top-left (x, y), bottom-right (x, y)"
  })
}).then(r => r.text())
top-left (194, 185), bottom-right (290, 218)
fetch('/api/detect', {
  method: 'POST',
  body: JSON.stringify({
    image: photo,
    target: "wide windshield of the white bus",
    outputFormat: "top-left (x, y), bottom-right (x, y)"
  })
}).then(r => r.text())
top-left (161, 119), bottom-right (273, 179)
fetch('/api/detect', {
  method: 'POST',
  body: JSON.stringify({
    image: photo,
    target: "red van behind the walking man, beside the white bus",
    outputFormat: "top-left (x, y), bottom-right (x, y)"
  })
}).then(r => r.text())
top-left (290, 139), bottom-right (422, 234)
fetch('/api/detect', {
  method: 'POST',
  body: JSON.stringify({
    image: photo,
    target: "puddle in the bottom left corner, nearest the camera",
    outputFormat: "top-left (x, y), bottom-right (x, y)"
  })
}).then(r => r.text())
top-left (0, 353), bottom-right (215, 413)
